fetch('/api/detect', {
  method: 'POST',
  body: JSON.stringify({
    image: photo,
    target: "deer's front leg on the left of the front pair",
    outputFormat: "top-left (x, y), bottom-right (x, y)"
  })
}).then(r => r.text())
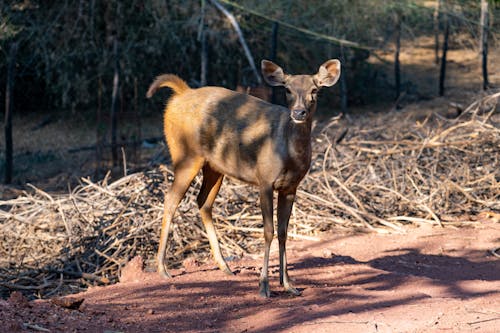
top-left (259, 186), bottom-right (274, 297)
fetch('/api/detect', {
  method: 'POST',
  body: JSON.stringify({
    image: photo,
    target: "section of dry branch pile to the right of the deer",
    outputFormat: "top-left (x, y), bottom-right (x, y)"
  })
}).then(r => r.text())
top-left (308, 93), bottom-right (500, 229)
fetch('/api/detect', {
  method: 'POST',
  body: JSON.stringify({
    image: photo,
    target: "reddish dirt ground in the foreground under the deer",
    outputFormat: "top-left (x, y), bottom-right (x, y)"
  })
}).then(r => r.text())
top-left (0, 218), bottom-right (500, 332)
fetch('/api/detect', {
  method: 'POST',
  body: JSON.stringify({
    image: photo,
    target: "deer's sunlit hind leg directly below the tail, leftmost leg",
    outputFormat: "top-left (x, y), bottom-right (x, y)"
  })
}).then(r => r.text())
top-left (158, 157), bottom-right (205, 278)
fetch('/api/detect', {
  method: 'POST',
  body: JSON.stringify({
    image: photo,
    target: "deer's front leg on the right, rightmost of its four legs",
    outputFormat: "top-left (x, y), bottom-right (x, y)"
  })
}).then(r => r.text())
top-left (278, 191), bottom-right (300, 296)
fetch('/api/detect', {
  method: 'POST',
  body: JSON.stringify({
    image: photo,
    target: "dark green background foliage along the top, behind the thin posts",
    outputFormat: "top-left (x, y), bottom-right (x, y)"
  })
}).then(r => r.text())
top-left (0, 0), bottom-right (498, 114)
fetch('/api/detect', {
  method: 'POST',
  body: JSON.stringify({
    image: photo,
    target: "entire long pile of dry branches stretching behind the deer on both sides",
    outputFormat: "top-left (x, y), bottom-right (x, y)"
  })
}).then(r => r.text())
top-left (0, 94), bottom-right (500, 297)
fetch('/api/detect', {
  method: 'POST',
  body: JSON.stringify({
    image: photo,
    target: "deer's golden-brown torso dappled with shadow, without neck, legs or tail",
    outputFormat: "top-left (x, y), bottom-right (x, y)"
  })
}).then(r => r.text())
top-left (165, 87), bottom-right (290, 184)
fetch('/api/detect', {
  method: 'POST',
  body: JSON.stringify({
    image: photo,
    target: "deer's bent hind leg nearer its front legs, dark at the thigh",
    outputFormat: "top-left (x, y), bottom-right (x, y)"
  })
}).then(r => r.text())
top-left (198, 164), bottom-right (233, 274)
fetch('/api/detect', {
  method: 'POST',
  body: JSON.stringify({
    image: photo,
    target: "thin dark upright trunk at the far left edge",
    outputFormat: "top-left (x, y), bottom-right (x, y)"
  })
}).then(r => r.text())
top-left (4, 42), bottom-right (17, 184)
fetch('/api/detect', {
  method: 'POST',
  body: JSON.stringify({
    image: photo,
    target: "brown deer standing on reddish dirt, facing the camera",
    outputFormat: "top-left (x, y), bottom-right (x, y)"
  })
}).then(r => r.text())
top-left (147, 59), bottom-right (340, 297)
